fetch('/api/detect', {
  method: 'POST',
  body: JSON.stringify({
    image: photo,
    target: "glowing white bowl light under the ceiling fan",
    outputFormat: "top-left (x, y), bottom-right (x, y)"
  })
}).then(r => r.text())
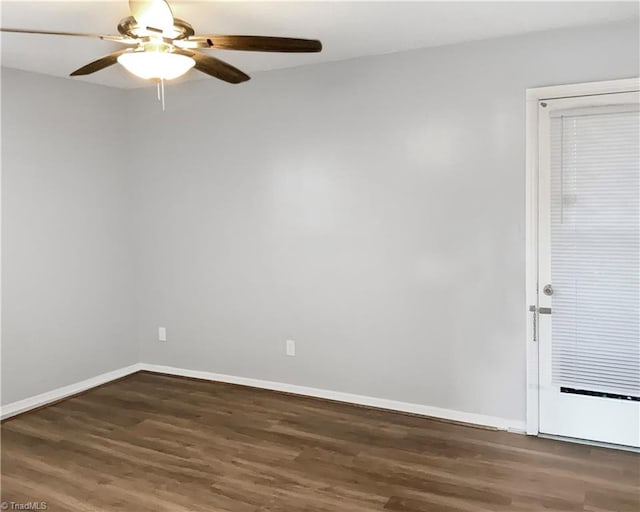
top-left (118, 51), bottom-right (196, 80)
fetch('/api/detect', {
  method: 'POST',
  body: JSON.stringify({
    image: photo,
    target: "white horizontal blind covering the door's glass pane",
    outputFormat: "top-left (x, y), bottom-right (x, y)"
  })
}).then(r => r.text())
top-left (551, 105), bottom-right (640, 397)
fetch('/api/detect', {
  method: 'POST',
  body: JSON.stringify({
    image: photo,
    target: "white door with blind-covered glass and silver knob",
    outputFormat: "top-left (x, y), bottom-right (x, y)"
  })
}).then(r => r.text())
top-left (537, 92), bottom-right (640, 447)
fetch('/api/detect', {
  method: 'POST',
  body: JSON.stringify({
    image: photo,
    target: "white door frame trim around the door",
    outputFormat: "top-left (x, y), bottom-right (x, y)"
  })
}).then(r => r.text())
top-left (524, 77), bottom-right (640, 435)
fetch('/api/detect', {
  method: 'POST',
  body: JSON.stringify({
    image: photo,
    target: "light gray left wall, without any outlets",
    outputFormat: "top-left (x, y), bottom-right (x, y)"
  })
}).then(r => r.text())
top-left (2, 69), bottom-right (138, 404)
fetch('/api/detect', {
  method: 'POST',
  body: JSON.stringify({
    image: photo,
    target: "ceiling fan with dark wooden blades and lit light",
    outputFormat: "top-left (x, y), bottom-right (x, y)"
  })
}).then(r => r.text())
top-left (0, 0), bottom-right (322, 84)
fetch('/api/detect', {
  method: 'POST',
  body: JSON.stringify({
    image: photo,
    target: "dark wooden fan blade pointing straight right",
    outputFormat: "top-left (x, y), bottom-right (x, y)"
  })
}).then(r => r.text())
top-left (188, 35), bottom-right (322, 53)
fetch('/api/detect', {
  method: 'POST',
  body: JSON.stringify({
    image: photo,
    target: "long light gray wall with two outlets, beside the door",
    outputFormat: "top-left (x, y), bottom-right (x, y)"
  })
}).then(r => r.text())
top-left (129, 23), bottom-right (639, 420)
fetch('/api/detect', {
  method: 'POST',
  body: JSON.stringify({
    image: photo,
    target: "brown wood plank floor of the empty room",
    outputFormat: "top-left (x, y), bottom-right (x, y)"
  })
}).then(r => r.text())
top-left (2, 373), bottom-right (640, 512)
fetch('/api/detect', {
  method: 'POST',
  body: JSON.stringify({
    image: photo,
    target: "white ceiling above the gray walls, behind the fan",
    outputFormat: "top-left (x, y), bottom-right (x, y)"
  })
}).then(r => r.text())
top-left (0, 0), bottom-right (639, 88)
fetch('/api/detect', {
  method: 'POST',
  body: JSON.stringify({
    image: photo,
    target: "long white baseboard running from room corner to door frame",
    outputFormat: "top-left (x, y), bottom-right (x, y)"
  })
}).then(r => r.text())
top-left (140, 363), bottom-right (525, 433)
